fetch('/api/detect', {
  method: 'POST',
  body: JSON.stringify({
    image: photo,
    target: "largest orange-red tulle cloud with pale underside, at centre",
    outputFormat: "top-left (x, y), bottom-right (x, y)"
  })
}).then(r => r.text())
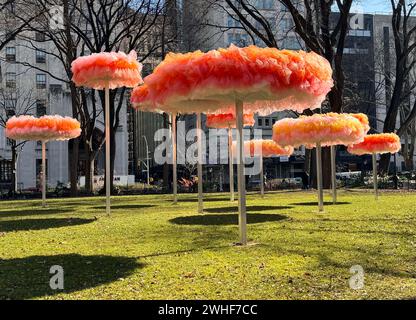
top-left (138, 45), bottom-right (333, 115)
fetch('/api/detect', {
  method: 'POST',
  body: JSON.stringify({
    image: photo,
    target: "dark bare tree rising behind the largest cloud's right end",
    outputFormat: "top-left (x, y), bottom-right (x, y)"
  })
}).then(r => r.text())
top-left (200, 0), bottom-right (353, 188)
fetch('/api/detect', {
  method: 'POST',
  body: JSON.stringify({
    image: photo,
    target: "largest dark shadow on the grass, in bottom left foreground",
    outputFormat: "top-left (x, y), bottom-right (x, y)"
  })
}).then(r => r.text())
top-left (0, 254), bottom-right (143, 300)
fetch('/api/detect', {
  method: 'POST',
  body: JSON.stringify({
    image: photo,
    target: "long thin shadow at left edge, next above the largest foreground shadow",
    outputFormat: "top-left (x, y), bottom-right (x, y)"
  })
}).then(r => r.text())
top-left (0, 218), bottom-right (95, 232)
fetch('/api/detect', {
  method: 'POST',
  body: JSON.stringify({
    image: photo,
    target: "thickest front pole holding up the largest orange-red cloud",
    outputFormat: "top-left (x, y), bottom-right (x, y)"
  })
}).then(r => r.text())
top-left (235, 100), bottom-right (247, 245)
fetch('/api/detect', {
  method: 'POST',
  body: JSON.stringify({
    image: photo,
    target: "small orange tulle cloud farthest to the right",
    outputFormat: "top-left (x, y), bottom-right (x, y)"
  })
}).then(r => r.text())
top-left (348, 133), bottom-right (401, 156)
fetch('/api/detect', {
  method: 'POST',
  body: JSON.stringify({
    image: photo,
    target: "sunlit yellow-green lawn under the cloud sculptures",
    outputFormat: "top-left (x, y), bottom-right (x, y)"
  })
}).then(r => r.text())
top-left (0, 191), bottom-right (416, 299)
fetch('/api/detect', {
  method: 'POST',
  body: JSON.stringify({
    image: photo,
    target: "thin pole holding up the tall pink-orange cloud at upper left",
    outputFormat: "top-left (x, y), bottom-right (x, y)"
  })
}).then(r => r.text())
top-left (105, 84), bottom-right (111, 215)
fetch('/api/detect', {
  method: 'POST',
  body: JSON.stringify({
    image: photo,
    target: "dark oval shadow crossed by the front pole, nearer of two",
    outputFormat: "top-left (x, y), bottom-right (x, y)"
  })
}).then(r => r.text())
top-left (169, 213), bottom-right (287, 225)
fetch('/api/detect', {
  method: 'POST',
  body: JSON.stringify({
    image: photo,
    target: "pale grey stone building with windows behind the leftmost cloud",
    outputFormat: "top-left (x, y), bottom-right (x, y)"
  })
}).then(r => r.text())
top-left (0, 32), bottom-right (128, 189)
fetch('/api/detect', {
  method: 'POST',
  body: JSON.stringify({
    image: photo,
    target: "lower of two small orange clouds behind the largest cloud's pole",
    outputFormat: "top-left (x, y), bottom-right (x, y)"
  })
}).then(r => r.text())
top-left (233, 139), bottom-right (294, 158)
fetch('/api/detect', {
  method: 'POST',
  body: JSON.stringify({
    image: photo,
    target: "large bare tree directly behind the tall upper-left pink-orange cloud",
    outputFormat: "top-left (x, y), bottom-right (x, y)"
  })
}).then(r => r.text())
top-left (11, 0), bottom-right (176, 191)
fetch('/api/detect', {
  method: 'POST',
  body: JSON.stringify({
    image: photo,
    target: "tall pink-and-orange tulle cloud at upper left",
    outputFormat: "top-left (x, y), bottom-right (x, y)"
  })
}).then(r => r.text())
top-left (72, 51), bottom-right (143, 90)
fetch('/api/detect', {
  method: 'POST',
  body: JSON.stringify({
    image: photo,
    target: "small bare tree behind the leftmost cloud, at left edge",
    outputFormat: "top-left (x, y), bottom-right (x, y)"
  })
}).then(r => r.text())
top-left (0, 89), bottom-right (36, 194)
